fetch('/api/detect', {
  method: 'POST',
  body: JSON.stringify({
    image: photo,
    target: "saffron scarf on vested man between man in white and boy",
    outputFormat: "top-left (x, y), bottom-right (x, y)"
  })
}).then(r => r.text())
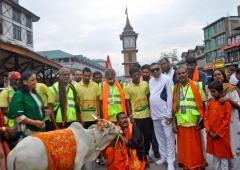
top-left (172, 79), bottom-right (204, 116)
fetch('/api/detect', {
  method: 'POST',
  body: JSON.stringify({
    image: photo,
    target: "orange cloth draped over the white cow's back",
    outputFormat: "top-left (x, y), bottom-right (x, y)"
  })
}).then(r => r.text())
top-left (32, 129), bottom-right (77, 170)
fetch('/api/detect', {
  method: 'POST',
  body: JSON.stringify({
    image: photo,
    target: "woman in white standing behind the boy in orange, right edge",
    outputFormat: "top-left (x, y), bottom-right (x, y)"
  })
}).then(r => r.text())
top-left (212, 70), bottom-right (240, 170)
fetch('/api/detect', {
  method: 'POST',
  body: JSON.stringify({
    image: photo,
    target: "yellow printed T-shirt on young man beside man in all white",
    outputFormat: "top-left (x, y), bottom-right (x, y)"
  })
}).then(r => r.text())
top-left (124, 81), bottom-right (150, 119)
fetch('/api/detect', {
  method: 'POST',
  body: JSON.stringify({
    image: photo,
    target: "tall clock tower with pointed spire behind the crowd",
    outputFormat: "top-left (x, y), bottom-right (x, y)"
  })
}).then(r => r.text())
top-left (120, 10), bottom-right (138, 79)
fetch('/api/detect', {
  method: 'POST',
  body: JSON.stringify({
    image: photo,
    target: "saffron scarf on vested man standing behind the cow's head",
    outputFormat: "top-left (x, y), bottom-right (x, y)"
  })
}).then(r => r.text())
top-left (102, 80), bottom-right (126, 120)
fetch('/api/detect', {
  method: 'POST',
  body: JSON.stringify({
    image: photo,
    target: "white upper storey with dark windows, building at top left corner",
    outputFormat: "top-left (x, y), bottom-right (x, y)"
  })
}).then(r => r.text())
top-left (0, 0), bottom-right (39, 50)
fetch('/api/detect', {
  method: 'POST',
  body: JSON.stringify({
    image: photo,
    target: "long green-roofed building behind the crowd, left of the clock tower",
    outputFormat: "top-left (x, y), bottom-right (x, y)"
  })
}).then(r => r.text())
top-left (37, 50), bottom-right (104, 74)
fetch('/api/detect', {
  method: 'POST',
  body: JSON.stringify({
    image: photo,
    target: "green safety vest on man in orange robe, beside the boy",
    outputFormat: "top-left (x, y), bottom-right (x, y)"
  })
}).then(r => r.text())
top-left (176, 82), bottom-right (203, 126)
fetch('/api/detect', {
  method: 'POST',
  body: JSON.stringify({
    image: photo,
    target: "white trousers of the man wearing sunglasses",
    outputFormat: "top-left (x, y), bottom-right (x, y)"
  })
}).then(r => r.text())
top-left (153, 118), bottom-right (175, 164)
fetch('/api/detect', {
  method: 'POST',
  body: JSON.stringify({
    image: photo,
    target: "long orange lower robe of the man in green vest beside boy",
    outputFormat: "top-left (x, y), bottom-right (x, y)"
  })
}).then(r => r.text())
top-left (177, 126), bottom-right (205, 169)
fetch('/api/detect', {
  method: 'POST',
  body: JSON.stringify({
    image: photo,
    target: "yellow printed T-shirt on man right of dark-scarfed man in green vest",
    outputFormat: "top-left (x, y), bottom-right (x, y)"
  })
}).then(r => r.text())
top-left (75, 81), bottom-right (100, 122)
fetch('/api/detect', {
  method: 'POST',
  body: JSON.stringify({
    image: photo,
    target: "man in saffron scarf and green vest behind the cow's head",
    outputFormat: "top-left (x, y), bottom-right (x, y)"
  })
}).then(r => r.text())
top-left (100, 69), bottom-right (127, 123)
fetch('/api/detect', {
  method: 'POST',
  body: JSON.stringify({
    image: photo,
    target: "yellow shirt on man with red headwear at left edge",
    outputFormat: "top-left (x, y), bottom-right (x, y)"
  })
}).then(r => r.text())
top-left (0, 86), bottom-right (15, 108)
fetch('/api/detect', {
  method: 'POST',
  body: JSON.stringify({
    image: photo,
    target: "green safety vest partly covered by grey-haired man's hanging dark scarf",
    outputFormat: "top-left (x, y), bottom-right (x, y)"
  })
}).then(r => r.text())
top-left (52, 82), bottom-right (77, 122)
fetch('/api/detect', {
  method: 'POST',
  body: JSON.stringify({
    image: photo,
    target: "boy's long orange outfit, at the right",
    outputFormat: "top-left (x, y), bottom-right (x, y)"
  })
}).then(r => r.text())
top-left (204, 100), bottom-right (233, 159)
